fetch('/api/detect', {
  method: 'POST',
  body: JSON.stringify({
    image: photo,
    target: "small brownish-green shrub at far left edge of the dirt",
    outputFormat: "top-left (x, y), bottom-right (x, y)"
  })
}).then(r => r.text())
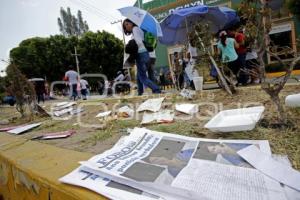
top-left (6, 64), bottom-right (36, 117)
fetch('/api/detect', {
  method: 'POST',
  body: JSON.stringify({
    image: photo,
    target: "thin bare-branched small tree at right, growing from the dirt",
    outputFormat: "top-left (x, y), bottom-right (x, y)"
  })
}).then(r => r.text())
top-left (240, 0), bottom-right (300, 125)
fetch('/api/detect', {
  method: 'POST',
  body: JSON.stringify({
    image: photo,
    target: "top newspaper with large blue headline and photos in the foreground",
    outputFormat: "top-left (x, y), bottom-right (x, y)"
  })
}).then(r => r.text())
top-left (76, 128), bottom-right (286, 200)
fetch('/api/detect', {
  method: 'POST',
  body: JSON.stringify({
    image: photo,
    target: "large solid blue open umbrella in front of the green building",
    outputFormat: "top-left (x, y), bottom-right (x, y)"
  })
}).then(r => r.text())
top-left (159, 5), bottom-right (239, 45)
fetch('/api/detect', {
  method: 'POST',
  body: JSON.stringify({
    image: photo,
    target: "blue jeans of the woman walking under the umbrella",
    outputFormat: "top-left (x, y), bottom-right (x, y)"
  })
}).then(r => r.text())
top-left (136, 52), bottom-right (160, 95)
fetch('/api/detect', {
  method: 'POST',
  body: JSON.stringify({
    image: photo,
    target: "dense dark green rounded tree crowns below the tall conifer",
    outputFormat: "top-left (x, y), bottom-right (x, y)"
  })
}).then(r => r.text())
top-left (10, 31), bottom-right (123, 81)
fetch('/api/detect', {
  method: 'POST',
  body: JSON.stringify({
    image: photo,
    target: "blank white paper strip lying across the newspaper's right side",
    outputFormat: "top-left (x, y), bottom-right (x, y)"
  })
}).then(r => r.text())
top-left (237, 145), bottom-right (300, 191)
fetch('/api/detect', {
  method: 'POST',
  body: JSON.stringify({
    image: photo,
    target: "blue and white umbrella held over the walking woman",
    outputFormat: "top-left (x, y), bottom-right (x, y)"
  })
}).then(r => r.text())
top-left (119, 6), bottom-right (163, 37)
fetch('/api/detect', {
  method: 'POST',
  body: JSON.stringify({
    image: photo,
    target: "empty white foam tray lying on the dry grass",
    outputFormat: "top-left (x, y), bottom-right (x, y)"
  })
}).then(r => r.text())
top-left (204, 106), bottom-right (265, 132)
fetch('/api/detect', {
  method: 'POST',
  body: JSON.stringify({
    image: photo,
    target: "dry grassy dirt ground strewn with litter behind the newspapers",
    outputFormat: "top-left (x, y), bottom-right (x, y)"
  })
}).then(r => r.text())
top-left (0, 85), bottom-right (300, 170)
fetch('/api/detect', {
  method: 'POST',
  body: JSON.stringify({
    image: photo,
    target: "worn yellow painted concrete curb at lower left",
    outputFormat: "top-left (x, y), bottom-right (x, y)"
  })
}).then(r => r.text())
top-left (0, 133), bottom-right (106, 200)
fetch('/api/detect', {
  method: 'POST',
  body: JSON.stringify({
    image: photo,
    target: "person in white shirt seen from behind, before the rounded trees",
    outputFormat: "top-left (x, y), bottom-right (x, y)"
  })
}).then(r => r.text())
top-left (64, 65), bottom-right (79, 101)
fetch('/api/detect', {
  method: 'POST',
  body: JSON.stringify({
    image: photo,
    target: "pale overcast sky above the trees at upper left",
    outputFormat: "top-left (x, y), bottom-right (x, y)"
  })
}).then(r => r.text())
top-left (0, 0), bottom-right (135, 76)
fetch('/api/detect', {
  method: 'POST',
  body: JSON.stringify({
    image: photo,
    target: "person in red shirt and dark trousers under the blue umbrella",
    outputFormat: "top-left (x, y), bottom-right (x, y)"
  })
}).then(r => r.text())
top-left (228, 28), bottom-right (249, 85)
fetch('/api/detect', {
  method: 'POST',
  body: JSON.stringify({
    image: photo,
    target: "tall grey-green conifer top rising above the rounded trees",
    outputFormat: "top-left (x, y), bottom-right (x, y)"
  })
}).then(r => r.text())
top-left (57, 7), bottom-right (89, 36)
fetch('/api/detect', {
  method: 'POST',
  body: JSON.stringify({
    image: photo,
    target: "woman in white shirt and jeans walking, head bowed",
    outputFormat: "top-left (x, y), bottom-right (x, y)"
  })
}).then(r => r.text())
top-left (123, 19), bottom-right (161, 95)
